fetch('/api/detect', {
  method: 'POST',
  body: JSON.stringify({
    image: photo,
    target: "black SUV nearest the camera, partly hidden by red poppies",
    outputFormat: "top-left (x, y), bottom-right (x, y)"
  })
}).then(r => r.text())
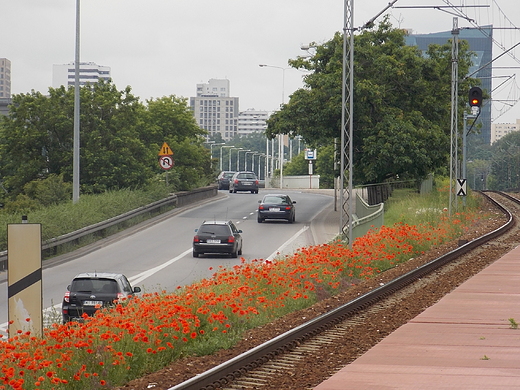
top-left (61, 272), bottom-right (141, 323)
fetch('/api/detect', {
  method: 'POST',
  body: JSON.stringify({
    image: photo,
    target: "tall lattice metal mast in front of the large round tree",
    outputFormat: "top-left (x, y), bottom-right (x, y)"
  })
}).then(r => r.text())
top-left (339, 0), bottom-right (354, 247)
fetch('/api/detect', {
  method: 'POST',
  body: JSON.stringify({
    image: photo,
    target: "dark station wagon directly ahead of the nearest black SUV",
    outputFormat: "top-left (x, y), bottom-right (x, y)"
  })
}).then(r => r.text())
top-left (193, 221), bottom-right (242, 258)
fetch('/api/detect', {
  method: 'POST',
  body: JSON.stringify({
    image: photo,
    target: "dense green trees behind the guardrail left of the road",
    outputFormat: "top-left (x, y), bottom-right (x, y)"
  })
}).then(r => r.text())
top-left (0, 81), bottom-right (213, 198)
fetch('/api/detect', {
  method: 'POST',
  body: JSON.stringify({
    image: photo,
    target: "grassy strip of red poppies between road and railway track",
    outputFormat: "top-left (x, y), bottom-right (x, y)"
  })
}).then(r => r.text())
top-left (0, 183), bottom-right (496, 389)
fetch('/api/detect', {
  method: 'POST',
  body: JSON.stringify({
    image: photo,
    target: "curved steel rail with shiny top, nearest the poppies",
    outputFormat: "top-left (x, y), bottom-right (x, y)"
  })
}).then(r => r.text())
top-left (168, 193), bottom-right (520, 390)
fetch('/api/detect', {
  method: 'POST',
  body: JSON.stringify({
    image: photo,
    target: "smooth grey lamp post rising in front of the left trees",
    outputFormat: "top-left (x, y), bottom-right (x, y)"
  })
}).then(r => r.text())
top-left (72, 0), bottom-right (80, 203)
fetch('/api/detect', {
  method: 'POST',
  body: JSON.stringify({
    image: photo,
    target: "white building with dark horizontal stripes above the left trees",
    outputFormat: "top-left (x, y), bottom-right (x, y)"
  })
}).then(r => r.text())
top-left (52, 62), bottom-right (111, 88)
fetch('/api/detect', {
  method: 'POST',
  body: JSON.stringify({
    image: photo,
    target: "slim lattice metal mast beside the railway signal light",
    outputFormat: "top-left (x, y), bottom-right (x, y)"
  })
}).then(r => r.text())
top-left (448, 17), bottom-right (459, 216)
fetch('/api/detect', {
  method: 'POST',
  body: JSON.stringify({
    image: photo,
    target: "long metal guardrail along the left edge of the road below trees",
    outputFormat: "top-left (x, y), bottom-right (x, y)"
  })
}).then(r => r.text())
top-left (0, 185), bottom-right (218, 271)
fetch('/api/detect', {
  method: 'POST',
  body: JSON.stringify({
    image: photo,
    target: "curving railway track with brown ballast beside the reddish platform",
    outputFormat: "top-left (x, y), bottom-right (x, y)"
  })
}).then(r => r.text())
top-left (164, 192), bottom-right (520, 390)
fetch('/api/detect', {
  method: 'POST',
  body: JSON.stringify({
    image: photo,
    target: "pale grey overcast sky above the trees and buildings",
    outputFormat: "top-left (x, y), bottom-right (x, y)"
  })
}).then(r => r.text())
top-left (4, 0), bottom-right (520, 122)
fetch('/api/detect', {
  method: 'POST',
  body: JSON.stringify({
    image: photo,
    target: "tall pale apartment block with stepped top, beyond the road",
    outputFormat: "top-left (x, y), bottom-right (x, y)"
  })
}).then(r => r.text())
top-left (190, 79), bottom-right (239, 141)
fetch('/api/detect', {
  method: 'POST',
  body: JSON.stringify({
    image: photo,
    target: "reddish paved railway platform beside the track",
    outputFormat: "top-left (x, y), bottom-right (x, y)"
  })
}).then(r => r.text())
top-left (314, 247), bottom-right (520, 390)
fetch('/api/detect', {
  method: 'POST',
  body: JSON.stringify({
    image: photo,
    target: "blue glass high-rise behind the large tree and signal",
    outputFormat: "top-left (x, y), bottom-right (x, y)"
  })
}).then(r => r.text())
top-left (406, 26), bottom-right (493, 144)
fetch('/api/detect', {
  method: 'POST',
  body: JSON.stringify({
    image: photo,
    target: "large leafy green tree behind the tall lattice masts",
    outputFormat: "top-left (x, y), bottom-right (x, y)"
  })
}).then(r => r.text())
top-left (267, 19), bottom-right (473, 184)
